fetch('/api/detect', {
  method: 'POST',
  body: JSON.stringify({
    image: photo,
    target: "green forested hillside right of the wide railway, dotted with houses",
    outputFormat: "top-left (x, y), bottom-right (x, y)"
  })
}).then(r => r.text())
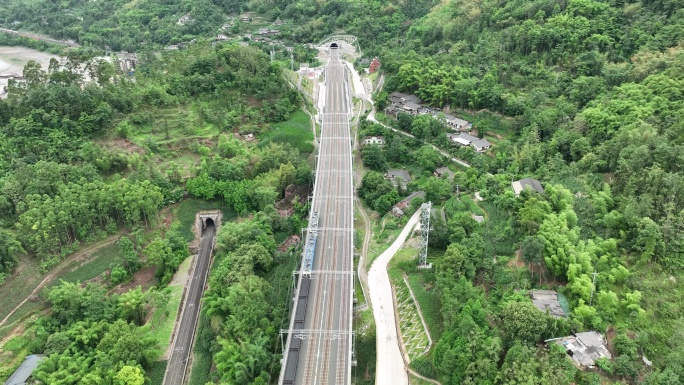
top-left (366, 0), bottom-right (684, 384)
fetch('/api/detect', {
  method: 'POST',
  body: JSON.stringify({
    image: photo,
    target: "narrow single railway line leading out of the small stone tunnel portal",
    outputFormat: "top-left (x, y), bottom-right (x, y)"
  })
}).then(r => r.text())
top-left (164, 223), bottom-right (216, 385)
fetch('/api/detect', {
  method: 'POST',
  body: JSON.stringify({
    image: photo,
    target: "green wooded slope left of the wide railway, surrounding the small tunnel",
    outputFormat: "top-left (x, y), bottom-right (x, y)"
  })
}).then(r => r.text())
top-left (0, 43), bottom-right (312, 384)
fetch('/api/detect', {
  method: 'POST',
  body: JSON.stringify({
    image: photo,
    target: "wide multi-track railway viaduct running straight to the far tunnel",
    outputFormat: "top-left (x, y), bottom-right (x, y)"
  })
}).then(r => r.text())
top-left (279, 45), bottom-right (354, 385)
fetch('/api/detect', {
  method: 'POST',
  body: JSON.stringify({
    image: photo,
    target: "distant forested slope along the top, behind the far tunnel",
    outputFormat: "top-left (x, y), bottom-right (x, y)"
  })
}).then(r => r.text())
top-left (0, 0), bottom-right (436, 51)
